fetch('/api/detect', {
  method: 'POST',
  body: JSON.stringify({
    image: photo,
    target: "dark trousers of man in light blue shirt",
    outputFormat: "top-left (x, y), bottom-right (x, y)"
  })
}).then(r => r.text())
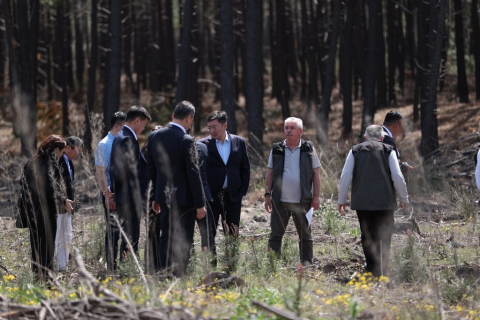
top-left (100, 192), bottom-right (120, 271)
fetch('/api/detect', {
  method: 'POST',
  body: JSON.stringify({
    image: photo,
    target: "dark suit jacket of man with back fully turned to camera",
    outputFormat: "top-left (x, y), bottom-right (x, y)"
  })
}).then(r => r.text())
top-left (147, 124), bottom-right (205, 209)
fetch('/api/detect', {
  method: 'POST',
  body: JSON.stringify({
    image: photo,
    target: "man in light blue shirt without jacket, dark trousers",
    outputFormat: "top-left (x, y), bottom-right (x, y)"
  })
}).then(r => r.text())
top-left (95, 111), bottom-right (127, 271)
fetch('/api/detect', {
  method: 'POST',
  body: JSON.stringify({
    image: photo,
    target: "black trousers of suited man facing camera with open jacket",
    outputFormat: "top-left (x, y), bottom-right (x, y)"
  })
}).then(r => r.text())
top-left (207, 189), bottom-right (242, 254)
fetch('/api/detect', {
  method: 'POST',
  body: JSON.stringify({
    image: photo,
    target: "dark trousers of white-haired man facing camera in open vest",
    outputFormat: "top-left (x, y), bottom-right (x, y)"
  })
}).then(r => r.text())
top-left (268, 202), bottom-right (313, 264)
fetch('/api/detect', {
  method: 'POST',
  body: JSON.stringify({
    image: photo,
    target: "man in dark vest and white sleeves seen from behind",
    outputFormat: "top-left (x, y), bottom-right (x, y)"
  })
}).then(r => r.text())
top-left (338, 125), bottom-right (408, 277)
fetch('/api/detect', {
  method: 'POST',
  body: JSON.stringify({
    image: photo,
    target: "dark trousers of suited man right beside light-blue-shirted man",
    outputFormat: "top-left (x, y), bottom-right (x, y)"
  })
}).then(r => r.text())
top-left (117, 203), bottom-right (141, 261)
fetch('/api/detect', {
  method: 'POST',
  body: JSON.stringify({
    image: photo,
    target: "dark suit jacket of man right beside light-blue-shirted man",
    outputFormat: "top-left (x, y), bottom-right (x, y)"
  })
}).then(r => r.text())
top-left (110, 127), bottom-right (149, 208)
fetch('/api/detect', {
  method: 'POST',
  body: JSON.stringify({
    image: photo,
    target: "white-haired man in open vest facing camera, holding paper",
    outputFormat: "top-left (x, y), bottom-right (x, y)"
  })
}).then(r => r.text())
top-left (265, 117), bottom-right (320, 266)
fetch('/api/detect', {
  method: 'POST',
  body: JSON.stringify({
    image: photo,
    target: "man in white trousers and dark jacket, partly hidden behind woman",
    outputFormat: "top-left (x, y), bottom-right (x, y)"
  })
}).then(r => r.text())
top-left (55, 136), bottom-right (83, 271)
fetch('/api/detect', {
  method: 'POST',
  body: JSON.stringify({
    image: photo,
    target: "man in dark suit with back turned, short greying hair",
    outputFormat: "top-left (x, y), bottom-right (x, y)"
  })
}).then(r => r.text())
top-left (147, 101), bottom-right (206, 277)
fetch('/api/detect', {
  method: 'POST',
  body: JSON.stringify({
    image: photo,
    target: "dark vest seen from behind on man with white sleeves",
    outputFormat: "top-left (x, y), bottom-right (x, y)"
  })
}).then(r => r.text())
top-left (351, 141), bottom-right (397, 211)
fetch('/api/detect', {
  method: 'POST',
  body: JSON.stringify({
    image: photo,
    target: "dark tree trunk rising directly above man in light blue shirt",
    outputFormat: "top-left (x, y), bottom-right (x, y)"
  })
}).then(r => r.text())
top-left (103, 1), bottom-right (122, 134)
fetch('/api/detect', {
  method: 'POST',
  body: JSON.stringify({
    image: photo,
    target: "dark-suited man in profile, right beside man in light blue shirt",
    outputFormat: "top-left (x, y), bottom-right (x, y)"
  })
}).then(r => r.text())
top-left (107, 106), bottom-right (152, 260)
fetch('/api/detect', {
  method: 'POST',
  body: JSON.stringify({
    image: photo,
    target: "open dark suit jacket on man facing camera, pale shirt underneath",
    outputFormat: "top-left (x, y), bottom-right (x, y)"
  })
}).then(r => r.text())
top-left (199, 133), bottom-right (250, 202)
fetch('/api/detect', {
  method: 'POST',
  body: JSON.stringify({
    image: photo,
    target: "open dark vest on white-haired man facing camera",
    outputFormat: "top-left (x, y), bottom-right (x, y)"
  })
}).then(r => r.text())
top-left (272, 140), bottom-right (313, 203)
